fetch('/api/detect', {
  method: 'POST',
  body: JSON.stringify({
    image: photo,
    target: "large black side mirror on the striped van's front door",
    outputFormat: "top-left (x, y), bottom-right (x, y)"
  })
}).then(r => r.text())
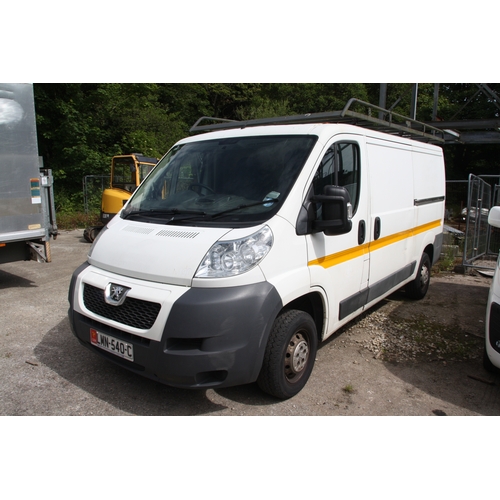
top-left (311, 186), bottom-right (352, 236)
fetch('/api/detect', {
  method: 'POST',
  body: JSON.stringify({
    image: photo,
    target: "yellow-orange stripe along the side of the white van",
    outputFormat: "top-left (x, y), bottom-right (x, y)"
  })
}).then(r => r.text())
top-left (308, 219), bottom-right (441, 269)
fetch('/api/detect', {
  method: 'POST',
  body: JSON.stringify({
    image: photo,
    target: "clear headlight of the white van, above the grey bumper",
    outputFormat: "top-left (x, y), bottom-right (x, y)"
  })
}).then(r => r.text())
top-left (195, 226), bottom-right (273, 278)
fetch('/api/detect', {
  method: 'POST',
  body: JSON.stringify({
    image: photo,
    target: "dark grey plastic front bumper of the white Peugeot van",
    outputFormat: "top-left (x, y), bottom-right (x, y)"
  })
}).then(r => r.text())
top-left (68, 265), bottom-right (282, 388)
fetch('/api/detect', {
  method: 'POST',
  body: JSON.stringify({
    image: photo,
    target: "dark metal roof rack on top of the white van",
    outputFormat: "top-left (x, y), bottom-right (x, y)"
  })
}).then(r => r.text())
top-left (189, 98), bottom-right (445, 143)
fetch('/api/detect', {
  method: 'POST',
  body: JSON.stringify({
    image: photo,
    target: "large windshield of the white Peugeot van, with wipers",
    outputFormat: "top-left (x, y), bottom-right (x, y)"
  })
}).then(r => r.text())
top-left (121, 135), bottom-right (317, 226)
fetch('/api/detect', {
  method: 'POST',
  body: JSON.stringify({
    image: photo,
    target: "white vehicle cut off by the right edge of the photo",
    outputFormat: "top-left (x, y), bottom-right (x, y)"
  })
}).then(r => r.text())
top-left (483, 207), bottom-right (500, 372)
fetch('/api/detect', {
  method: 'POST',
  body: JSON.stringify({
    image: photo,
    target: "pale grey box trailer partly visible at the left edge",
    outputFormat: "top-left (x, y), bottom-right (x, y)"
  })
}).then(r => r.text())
top-left (0, 83), bottom-right (57, 264)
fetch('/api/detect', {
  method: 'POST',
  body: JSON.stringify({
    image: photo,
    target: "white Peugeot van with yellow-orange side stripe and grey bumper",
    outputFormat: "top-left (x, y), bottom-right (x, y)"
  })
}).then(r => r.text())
top-left (69, 109), bottom-right (445, 398)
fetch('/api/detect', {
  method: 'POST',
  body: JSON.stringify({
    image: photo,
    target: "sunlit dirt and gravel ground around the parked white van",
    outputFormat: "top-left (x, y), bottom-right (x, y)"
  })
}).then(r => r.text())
top-left (0, 231), bottom-right (500, 416)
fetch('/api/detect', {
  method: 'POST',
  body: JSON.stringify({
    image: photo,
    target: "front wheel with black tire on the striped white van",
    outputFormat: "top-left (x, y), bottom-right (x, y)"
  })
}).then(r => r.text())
top-left (257, 309), bottom-right (318, 399)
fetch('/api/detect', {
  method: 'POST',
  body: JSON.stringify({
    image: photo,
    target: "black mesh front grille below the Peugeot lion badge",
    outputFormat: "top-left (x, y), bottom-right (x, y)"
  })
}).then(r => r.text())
top-left (83, 283), bottom-right (161, 330)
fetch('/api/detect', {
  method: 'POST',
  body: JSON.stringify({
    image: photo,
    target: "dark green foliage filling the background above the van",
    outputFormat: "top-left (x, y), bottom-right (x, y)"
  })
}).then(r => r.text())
top-left (34, 83), bottom-right (500, 213)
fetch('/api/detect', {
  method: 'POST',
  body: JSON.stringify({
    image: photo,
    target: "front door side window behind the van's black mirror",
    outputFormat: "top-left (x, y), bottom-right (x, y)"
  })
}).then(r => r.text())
top-left (313, 142), bottom-right (360, 216)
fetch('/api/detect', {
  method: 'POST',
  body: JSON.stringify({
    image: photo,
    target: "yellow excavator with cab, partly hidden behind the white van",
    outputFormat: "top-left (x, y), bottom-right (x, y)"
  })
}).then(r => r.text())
top-left (83, 153), bottom-right (158, 243)
